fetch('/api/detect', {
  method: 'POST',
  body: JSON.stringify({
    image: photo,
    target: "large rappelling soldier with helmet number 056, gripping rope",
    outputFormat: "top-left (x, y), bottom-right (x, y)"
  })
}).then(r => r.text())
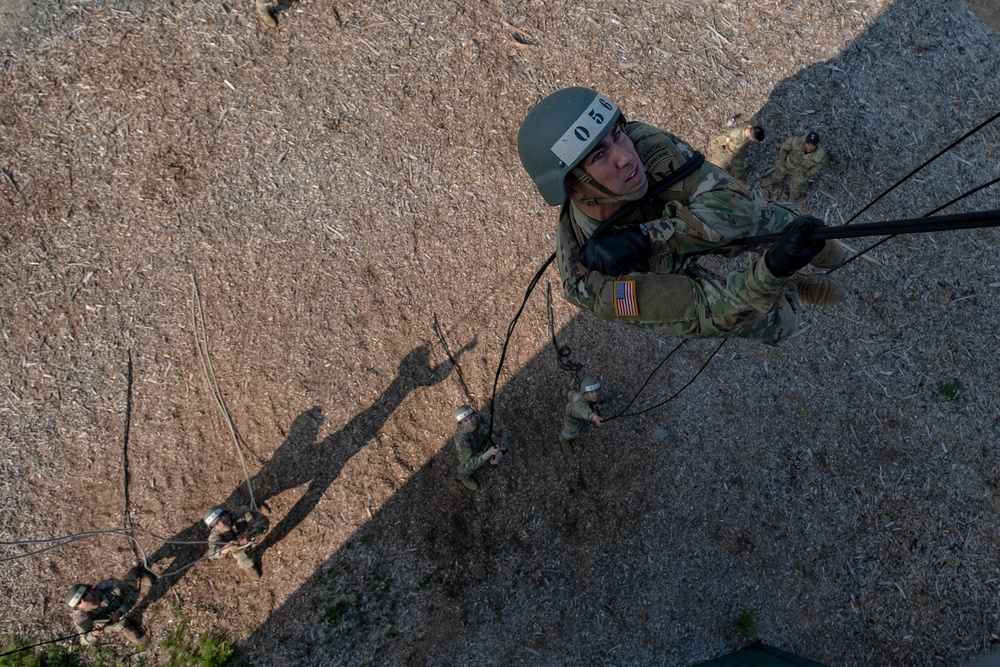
top-left (517, 88), bottom-right (846, 343)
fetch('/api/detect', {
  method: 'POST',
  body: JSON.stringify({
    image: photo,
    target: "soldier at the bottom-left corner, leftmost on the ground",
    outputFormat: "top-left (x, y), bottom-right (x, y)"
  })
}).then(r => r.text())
top-left (66, 564), bottom-right (156, 646)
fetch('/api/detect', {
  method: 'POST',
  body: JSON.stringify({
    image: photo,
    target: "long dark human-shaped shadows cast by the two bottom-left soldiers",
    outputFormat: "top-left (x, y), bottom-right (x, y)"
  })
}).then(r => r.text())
top-left (133, 340), bottom-right (476, 618)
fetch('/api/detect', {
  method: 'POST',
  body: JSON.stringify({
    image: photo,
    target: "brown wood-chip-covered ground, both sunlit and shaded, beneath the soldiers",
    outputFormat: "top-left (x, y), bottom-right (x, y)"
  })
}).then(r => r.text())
top-left (0, 0), bottom-right (1000, 667)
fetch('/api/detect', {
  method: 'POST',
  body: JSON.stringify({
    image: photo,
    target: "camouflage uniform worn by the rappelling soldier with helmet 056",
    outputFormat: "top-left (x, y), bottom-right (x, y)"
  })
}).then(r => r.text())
top-left (556, 122), bottom-right (801, 342)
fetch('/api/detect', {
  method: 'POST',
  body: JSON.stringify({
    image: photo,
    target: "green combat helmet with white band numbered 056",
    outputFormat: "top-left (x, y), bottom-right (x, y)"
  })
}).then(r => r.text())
top-left (517, 88), bottom-right (646, 206)
